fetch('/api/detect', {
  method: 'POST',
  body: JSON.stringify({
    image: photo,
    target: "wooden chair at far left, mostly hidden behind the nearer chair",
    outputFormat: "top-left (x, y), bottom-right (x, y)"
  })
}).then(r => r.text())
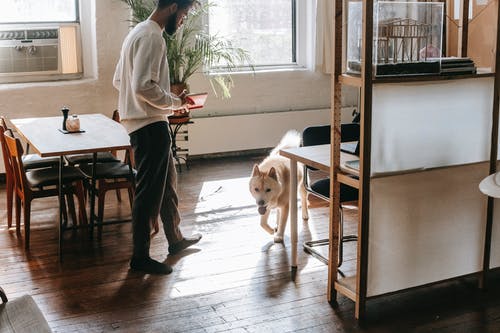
top-left (0, 116), bottom-right (59, 228)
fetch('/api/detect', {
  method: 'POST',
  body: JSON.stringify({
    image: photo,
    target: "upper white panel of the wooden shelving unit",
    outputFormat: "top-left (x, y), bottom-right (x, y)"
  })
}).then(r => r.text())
top-left (371, 78), bottom-right (493, 174)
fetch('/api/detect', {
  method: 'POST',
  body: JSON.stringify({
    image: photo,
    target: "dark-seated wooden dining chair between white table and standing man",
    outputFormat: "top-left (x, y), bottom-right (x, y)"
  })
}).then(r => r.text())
top-left (78, 110), bottom-right (135, 238)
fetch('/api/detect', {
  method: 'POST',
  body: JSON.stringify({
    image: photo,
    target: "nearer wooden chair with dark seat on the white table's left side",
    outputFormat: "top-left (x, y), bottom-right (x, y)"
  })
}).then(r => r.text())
top-left (3, 130), bottom-right (87, 250)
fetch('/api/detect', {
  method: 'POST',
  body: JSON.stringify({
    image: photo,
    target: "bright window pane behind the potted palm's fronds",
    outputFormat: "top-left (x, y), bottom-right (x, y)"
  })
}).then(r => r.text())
top-left (209, 0), bottom-right (295, 66)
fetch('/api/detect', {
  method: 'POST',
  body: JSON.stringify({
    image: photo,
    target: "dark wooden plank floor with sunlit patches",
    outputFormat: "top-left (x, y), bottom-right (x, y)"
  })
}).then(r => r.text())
top-left (0, 157), bottom-right (500, 333)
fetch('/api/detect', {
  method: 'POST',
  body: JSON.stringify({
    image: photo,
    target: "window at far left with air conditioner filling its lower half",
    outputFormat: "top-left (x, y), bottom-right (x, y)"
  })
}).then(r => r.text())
top-left (0, 0), bottom-right (82, 83)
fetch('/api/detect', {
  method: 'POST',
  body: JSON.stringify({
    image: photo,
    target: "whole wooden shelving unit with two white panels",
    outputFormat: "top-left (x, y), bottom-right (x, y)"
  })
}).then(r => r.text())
top-left (328, 0), bottom-right (500, 319)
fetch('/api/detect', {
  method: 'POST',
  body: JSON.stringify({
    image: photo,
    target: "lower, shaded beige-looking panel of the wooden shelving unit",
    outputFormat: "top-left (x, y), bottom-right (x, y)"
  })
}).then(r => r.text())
top-left (368, 163), bottom-right (488, 296)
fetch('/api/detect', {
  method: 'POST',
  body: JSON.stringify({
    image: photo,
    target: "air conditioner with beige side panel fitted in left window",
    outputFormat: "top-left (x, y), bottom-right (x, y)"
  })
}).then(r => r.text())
top-left (0, 24), bottom-right (82, 83)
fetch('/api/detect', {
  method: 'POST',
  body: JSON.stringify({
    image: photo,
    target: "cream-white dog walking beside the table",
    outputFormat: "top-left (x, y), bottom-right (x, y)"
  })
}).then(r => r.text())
top-left (249, 130), bottom-right (309, 243)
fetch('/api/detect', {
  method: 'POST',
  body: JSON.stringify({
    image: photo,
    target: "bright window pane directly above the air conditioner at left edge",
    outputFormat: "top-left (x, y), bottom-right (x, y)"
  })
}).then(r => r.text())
top-left (0, 0), bottom-right (77, 23)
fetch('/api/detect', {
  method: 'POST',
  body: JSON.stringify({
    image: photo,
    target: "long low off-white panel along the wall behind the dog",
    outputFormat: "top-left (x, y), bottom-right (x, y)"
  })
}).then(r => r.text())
top-left (188, 109), bottom-right (330, 156)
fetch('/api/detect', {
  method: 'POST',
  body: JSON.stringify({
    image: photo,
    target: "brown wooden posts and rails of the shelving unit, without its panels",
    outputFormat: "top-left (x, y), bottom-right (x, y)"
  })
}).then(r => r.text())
top-left (327, 0), bottom-right (500, 320)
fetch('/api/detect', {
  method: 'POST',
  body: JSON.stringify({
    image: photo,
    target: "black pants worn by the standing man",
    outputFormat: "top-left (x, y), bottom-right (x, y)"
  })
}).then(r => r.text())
top-left (130, 122), bottom-right (182, 258)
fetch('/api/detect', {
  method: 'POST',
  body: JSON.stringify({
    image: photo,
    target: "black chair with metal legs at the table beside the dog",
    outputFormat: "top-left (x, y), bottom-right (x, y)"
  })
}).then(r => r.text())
top-left (302, 124), bottom-right (359, 267)
